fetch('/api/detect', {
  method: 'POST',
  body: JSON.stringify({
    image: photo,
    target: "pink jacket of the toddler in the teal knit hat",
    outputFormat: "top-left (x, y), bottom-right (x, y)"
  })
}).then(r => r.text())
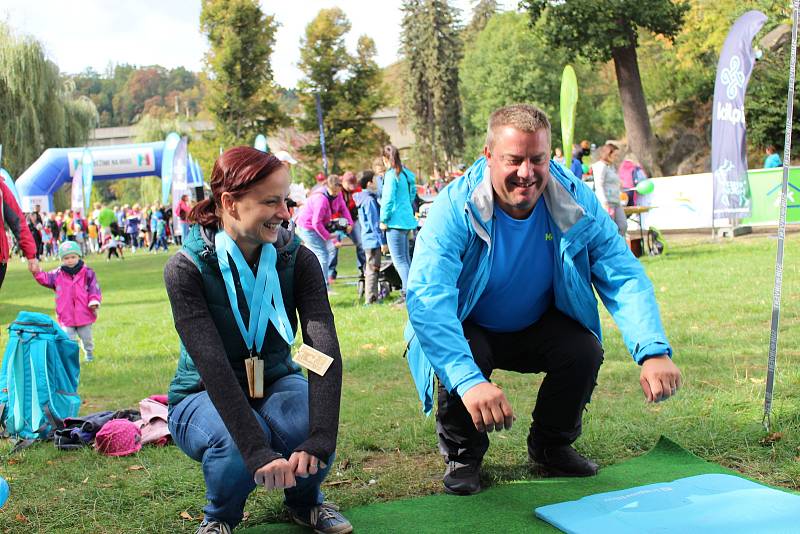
top-left (34, 265), bottom-right (102, 327)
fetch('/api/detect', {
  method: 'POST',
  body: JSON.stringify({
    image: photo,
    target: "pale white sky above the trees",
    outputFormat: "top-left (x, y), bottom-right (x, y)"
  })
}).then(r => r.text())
top-left (0, 0), bottom-right (518, 87)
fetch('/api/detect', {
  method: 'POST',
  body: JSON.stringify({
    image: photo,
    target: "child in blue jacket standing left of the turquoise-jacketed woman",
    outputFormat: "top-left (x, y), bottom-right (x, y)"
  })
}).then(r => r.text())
top-left (354, 171), bottom-right (386, 305)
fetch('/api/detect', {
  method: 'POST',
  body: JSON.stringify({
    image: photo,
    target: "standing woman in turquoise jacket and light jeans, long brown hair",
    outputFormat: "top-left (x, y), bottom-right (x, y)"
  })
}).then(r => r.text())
top-left (380, 145), bottom-right (417, 303)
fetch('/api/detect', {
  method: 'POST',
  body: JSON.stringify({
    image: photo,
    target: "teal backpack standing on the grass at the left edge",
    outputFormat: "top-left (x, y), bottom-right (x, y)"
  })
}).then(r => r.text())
top-left (0, 311), bottom-right (81, 450)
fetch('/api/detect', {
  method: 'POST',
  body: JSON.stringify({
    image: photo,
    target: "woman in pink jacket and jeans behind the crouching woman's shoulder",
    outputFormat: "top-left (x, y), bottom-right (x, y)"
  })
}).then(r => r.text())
top-left (295, 174), bottom-right (353, 287)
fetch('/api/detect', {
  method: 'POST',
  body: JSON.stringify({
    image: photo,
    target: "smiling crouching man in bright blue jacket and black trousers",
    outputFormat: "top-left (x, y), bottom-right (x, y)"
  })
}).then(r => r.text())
top-left (406, 105), bottom-right (681, 495)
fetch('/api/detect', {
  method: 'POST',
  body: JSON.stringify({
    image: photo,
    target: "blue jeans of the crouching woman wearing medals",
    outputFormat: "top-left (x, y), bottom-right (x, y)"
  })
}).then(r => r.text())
top-left (169, 374), bottom-right (333, 527)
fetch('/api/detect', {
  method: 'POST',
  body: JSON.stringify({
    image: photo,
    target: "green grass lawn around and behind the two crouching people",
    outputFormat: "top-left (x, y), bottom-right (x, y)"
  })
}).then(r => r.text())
top-left (0, 234), bottom-right (800, 532)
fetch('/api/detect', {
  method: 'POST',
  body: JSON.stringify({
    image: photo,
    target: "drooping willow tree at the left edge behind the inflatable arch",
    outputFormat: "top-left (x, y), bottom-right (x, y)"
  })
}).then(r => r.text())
top-left (0, 22), bottom-right (97, 176)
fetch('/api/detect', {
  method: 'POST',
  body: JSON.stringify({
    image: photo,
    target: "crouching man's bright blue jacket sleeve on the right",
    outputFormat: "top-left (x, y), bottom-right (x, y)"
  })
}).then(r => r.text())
top-left (581, 187), bottom-right (672, 364)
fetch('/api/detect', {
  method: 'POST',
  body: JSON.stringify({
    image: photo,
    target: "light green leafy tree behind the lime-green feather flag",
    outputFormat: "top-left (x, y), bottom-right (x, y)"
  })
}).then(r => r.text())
top-left (460, 12), bottom-right (623, 160)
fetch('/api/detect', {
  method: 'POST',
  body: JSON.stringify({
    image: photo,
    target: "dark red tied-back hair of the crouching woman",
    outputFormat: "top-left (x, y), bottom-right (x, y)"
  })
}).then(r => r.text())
top-left (189, 146), bottom-right (283, 226)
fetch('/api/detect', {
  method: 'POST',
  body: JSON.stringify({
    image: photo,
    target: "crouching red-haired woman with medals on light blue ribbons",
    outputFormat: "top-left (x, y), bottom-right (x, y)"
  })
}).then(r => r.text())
top-left (164, 147), bottom-right (352, 533)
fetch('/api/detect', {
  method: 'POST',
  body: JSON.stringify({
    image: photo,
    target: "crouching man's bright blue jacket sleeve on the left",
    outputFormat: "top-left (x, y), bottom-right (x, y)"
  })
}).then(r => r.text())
top-left (406, 186), bottom-right (487, 395)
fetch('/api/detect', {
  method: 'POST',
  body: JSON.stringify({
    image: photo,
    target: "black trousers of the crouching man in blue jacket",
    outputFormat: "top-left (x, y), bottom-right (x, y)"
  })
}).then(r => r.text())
top-left (436, 307), bottom-right (603, 464)
